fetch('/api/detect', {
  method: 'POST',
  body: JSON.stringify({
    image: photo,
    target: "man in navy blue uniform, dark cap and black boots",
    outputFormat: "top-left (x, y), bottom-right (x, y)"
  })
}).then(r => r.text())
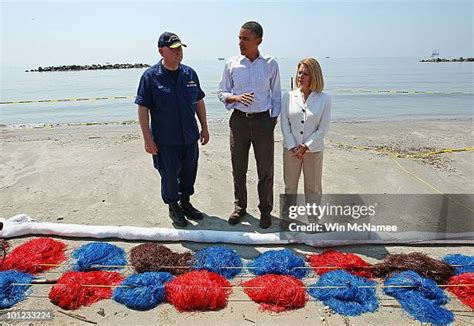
top-left (135, 32), bottom-right (209, 227)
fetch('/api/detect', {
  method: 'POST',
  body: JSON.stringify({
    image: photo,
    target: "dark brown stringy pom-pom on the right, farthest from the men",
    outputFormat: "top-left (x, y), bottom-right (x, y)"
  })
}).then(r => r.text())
top-left (372, 252), bottom-right (454, 284)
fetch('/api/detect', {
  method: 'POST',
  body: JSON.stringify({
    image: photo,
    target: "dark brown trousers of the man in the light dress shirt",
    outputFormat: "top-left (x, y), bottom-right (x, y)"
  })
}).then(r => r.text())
top-left (229, 110), bottom-right (276, 214)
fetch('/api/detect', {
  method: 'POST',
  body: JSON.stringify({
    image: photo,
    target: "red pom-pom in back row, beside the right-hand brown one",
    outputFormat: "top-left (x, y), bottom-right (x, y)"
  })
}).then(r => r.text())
top-left (307, 250), bottom-right (372, 278)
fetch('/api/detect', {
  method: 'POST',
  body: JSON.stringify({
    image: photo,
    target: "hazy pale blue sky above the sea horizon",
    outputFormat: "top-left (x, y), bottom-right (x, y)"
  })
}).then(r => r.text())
top-left (1, 0), bottom-right (474, 67)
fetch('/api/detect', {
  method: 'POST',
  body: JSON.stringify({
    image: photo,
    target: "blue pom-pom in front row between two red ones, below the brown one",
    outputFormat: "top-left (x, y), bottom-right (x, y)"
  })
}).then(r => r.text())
top-left (113, 272), bottom-right (173, 310)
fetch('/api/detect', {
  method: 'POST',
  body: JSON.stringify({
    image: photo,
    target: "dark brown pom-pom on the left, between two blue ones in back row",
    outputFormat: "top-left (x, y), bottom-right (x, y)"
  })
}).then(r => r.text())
top-left (130, 242), bottom-right (193, 275)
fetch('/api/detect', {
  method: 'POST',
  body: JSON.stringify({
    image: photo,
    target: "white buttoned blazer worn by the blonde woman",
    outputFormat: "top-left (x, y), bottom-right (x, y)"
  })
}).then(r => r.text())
top-left (281, 89), bottom-right (331, 152)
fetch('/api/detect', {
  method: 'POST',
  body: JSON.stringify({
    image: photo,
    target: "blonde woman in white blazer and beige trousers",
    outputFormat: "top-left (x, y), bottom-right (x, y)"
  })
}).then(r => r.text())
top-left (281, 58), bottom-right (331, 210)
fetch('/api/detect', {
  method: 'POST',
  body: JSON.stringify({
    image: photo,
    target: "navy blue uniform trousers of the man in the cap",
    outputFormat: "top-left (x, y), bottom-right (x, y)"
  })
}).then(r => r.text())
top-left (153, 142), bottom-right (199, 204)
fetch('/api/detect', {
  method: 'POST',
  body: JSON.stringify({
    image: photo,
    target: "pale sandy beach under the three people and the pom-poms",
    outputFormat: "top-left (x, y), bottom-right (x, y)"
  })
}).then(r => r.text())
top-left (0, 120), bottom-right (474, 325)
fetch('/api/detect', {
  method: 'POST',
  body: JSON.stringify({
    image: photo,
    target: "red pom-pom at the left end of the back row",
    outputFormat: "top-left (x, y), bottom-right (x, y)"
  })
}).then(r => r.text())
top-left (0, 238), bottom-right (66, 274)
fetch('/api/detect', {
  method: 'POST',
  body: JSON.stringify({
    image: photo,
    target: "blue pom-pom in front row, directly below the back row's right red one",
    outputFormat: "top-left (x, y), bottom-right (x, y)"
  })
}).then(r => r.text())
top-left (308, 270), bottom-right (379, 316)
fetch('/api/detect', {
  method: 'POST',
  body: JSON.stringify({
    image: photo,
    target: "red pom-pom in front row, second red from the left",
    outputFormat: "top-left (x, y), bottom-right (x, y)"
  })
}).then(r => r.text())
top-left (165, 270), bottom-right (232, 311)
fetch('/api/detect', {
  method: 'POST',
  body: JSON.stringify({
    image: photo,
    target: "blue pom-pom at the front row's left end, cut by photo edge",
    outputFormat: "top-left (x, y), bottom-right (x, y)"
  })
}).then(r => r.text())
top-left (0, 271), bottom-right (33, 309)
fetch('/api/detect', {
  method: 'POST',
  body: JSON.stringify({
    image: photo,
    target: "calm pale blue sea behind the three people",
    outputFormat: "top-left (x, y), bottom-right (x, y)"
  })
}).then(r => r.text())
top-left (0, 58), bottom-right (474, 125)
